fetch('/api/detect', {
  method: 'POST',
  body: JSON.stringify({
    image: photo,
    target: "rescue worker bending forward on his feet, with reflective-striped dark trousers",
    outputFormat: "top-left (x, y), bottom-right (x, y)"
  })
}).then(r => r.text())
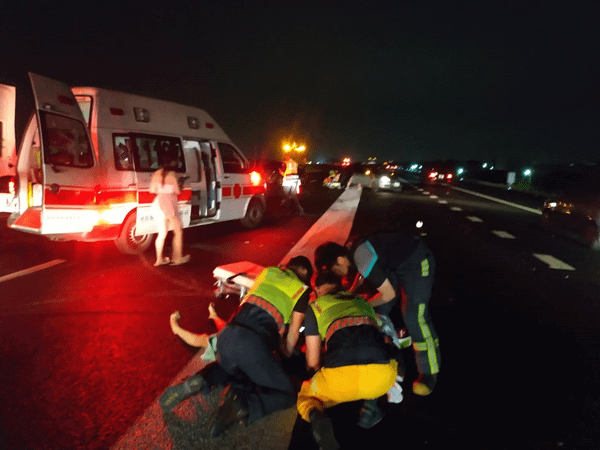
top-left (315, 232), bottom-right (440, 396)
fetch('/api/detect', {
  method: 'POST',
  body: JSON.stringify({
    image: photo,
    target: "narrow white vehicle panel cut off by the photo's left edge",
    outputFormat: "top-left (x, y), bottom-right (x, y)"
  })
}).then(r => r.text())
top-left (0, 84), bottom-right (17, 212)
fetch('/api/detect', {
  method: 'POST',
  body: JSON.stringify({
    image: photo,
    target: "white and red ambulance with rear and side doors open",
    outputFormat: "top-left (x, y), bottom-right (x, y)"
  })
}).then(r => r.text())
top-left (0, 73), bottom-right (266, 254)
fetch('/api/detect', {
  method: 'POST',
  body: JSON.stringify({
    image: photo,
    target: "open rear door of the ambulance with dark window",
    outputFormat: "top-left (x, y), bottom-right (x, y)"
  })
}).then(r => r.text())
top-left (9, 73), bottom-right (101, 238)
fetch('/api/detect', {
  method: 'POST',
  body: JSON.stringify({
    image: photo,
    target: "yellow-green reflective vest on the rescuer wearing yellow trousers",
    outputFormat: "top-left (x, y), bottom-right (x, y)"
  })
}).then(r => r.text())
top-left (310, 292), bottom-right (378, 345)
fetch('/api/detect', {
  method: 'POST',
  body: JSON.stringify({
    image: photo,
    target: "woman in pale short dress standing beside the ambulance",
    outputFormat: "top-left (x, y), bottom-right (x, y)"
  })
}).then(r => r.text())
top-left (150, 162), bottom-right (190, 266)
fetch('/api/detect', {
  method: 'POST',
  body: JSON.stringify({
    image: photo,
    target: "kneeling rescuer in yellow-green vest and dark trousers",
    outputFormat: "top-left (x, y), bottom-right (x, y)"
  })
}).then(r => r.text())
top-left (159, 256), bottom-right (313, 437)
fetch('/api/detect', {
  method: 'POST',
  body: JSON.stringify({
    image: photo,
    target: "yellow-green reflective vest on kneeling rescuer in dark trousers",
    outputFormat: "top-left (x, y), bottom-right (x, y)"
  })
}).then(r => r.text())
top-left (243, 267), bottom-right (308, 332)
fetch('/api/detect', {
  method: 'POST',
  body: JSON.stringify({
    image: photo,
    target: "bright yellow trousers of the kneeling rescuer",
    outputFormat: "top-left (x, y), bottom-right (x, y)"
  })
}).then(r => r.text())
top-left (297, 360), bottom-right (398, 422)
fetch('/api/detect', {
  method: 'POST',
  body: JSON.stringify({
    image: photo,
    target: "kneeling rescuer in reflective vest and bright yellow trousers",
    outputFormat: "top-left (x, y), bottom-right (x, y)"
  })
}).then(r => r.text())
top-left (297, 272), bottom-right (398, 450)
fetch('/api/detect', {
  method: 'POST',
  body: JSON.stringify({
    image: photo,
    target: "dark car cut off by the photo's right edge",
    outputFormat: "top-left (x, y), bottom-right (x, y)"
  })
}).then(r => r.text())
top-left (541, 169), bottom-right (600, 251)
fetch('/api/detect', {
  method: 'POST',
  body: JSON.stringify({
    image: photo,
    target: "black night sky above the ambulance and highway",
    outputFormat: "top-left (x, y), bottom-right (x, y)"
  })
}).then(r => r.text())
top-left (0, 0), bottom-right (600, 168)
